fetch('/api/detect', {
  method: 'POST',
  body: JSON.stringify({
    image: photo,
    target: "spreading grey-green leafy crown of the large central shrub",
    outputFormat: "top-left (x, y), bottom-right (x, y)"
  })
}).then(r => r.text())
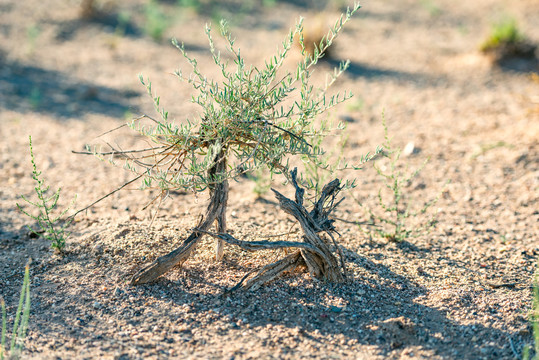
top-left (94, 4), bottom-right (372, 195)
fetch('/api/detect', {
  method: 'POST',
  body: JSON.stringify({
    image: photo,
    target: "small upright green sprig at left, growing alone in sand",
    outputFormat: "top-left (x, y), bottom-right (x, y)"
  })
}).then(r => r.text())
top-left (17, 136), bottom-right (75, 253)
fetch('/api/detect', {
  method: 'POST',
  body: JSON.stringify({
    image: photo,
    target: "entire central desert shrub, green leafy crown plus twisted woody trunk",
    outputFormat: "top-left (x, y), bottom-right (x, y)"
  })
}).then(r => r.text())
top-left (81, 4), bottom-right (380, 286)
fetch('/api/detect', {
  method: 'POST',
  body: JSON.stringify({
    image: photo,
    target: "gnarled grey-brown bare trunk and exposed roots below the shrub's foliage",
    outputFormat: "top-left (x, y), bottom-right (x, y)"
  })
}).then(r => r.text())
top-left (131, 169), bottom-right (346, 292)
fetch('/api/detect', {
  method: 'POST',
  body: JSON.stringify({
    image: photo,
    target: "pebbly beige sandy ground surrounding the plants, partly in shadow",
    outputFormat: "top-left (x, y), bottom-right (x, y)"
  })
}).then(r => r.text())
top-left (0, 0), bottom-right (539, 359)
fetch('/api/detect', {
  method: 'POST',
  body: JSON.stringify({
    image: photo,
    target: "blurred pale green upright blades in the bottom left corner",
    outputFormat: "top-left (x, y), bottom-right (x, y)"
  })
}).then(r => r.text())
top-left (0, 261), bottom-right (30, 360)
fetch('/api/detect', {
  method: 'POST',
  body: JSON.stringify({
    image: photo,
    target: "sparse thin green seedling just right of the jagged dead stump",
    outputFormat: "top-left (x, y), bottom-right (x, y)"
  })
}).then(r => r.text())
top-left (360, 119), bottom-right (438, 242)
